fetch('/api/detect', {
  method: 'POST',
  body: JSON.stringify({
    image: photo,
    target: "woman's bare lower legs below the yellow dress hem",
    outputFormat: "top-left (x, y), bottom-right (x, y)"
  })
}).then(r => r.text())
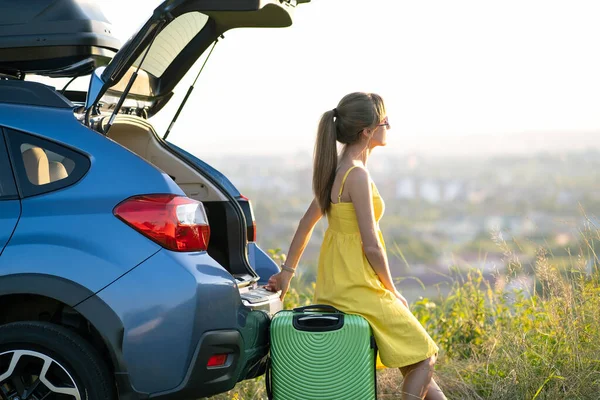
top-left (400, 356), bottom-right (446, 400)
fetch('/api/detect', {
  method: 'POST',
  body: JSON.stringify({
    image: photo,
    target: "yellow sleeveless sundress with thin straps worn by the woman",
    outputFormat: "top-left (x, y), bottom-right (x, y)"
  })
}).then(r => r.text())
top-left (314, 166), bottom-right (438, 368)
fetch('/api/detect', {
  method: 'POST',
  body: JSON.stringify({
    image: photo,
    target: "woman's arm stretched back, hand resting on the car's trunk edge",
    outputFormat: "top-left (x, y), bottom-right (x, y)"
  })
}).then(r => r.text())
top-left (266, 200), bottom-right (323, 300)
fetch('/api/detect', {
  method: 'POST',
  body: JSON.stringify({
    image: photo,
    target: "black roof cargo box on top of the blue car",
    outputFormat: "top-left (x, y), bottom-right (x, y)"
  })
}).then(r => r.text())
top-left (0, 0), bottom-right (121, 77)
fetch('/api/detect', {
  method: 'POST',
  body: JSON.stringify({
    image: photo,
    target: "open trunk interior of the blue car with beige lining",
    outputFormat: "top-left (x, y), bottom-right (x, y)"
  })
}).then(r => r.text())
top-left (101, 115), bottom-right (255, 287)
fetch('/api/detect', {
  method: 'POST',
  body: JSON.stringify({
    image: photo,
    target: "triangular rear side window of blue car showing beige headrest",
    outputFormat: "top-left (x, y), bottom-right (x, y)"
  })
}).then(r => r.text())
top-left (6, 129), bottom-right (90, 197)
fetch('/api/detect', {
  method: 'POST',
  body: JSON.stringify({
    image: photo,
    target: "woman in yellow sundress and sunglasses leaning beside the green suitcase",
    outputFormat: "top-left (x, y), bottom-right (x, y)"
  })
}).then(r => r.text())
top-left (267, 92), bottom-right (446, 400)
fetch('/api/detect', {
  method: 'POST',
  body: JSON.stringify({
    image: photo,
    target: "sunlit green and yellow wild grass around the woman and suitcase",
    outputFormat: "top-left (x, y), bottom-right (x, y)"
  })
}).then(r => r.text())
top-left (211, 229), bottom-right (600, 400)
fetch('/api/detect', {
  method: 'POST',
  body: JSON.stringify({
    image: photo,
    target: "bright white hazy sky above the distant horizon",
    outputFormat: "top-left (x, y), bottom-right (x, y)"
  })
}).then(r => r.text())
top-left (97, 0), bottom-right (600, 154)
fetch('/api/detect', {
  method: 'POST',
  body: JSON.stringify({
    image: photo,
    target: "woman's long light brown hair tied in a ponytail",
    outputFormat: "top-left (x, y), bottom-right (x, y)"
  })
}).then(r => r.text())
top-left (313, 92), bottom-right (386, 213)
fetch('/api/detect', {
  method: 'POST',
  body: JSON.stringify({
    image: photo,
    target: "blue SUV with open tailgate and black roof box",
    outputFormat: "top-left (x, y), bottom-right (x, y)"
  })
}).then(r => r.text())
top-left (0, 0), bottom-right (306, 400)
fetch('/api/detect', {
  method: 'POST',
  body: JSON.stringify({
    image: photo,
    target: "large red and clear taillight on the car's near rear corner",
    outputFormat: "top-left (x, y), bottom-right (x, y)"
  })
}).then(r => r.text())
top-left (114, 194), bottom-right (210, 251)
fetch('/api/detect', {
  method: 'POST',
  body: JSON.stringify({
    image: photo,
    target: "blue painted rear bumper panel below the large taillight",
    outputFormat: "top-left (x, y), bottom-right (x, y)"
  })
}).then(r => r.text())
top-left (85, 249), bottom-right (242, 393)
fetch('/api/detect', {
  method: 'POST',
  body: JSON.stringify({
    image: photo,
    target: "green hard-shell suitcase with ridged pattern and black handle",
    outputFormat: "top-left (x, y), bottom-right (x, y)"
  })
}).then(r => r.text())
top-left (267, 305), bottom-right (377, 400)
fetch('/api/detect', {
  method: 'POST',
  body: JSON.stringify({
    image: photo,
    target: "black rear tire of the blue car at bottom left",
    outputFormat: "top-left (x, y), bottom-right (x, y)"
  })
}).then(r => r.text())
top-left (0, 322), bottom-right (115, 400)
